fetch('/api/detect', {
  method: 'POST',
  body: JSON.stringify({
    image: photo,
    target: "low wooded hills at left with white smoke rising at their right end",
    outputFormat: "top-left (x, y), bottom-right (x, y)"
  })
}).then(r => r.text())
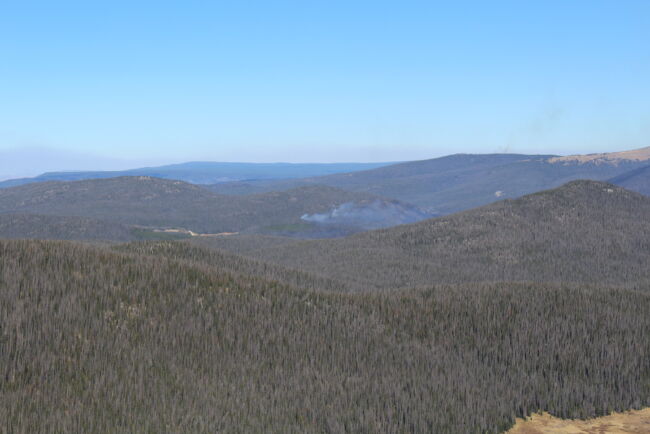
top-left (0, 177), bottom-right (428, 237)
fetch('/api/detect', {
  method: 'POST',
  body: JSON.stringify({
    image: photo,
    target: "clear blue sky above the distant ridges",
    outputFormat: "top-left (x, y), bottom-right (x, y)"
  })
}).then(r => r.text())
top-left (0, 0), bottom-right (650, 175)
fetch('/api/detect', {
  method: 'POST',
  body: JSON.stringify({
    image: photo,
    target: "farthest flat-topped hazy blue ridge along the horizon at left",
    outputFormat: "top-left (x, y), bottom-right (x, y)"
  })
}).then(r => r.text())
top-left (0, 162), bottom-right (391, 188)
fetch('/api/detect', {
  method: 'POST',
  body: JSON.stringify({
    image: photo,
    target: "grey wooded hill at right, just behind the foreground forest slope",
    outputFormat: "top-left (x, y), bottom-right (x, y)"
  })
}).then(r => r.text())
top-left (234, 181), bottom-right (650, 290)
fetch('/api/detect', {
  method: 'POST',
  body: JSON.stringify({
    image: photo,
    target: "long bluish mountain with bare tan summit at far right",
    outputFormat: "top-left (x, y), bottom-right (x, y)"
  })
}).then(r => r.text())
top-left (211, 148), bottom-right (650, 215)
